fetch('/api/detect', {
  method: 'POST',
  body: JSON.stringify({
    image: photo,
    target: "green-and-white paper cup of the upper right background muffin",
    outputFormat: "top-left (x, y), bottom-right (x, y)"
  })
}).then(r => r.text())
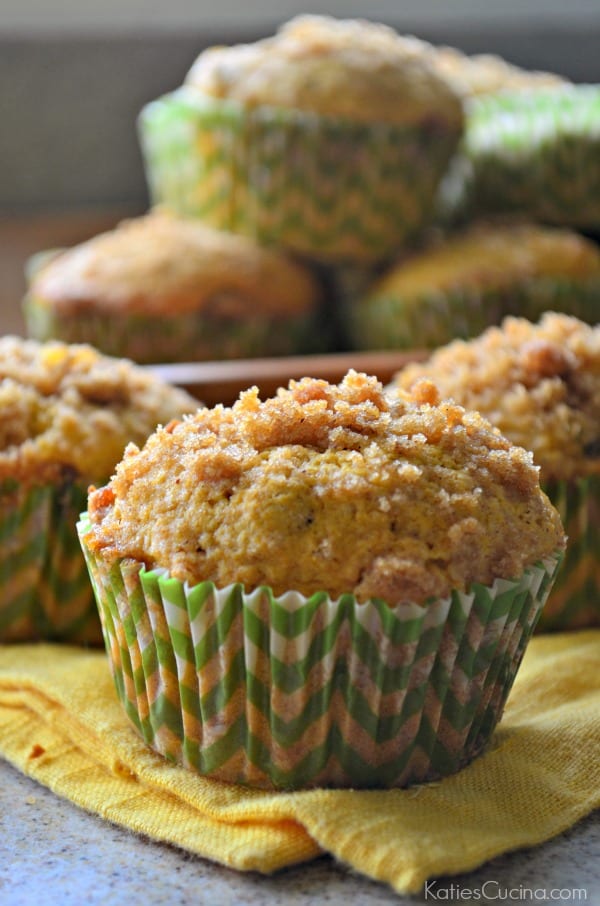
top-left (453, 85), bottom-right (600, 229)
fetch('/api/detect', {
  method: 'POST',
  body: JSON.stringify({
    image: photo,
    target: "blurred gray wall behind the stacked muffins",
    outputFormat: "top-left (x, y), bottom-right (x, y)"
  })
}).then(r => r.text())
top-left (0, 0), bottom-right (600, 214)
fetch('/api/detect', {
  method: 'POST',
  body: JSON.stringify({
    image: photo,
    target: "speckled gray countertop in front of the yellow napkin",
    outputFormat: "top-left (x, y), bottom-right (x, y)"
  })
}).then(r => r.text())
top-left (0, 761), bottom-right (600, 906)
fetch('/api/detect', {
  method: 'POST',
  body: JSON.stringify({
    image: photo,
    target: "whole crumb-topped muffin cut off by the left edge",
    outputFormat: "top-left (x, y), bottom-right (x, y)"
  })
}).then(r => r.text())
top-left (0, 337), bottom-right (199, 644)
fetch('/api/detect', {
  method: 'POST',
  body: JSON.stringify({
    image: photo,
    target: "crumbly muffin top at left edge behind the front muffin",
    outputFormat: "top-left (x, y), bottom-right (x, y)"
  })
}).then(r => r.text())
top-left (0, 337), bottom-right (199, 484)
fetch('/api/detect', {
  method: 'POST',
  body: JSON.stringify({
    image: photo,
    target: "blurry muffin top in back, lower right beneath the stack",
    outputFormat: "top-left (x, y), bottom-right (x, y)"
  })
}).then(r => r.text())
top-left (369, 224), bottom-right (600, 296)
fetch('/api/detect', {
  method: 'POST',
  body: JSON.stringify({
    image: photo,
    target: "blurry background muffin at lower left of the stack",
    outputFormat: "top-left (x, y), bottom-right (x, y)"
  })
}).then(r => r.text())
top-left (24, 211), bottom-right (319, 362)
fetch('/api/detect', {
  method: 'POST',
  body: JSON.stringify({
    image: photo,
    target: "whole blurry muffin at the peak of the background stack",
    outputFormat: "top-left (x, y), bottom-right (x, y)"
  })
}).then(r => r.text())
top-left (140, 16), bottom-right (463, 262)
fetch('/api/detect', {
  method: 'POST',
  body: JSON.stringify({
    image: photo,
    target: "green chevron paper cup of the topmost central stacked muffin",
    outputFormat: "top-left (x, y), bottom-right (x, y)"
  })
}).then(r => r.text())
top-left (139, 88), bottom-right (460, 261)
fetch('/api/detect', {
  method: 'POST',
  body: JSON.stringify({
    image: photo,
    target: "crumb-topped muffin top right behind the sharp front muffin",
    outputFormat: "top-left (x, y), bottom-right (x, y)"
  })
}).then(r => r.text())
top-left (392, 312), bottom-right (600, 481)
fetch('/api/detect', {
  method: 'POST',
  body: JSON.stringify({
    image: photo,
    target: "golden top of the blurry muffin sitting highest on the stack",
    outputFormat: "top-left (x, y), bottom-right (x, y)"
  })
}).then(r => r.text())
top-left (186, 16), bottom-right (463, 128)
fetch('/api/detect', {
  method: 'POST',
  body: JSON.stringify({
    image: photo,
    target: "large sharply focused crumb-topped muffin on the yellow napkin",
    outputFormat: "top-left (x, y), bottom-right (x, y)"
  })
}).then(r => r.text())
top-left (79, 371), bottom-right (564, 789)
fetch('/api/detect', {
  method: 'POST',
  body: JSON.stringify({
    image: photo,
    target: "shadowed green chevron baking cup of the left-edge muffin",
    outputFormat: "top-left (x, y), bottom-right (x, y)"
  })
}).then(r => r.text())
top-left (0, 479), bottom-right (102, 644)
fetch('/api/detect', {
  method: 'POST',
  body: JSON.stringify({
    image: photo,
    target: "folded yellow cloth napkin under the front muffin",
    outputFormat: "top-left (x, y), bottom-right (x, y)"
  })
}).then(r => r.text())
top-left (0, 630), bottom-right (600, 892)
